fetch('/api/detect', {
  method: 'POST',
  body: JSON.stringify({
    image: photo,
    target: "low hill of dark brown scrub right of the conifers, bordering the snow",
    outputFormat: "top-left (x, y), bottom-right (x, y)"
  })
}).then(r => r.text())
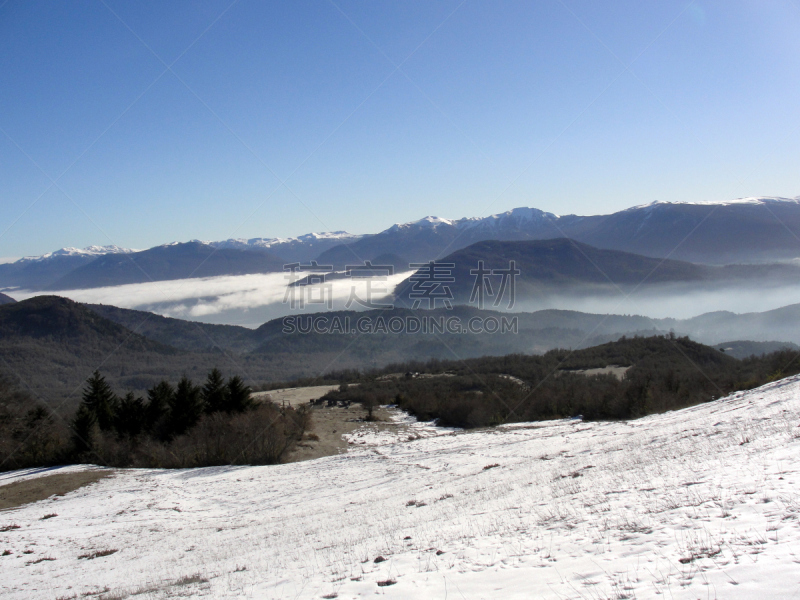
top-left (318, 335), bottom-right (800, 428)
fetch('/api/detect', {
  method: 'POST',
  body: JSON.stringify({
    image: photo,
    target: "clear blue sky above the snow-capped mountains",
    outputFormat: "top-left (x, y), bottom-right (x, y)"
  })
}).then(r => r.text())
top-left (0, 0), bottom-right (800, 257)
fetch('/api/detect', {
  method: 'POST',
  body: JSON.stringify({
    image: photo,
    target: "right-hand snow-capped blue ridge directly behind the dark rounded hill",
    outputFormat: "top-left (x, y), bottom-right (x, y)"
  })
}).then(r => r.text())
top-left (318, 197), bottom-right (800, 266)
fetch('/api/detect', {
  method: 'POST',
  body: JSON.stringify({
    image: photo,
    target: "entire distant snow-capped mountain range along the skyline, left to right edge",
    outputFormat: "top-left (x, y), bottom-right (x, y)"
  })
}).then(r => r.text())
top-left (0, 197), bottom-right (800, 290)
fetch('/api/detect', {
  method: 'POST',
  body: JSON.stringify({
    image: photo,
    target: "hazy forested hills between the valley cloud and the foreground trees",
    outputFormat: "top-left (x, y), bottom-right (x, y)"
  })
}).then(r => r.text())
top-left (0, 296), bottom-right (800, 402)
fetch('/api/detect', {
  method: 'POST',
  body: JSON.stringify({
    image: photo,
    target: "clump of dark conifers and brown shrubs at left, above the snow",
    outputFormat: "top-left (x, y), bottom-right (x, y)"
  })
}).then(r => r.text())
top-left (0, 369), bottom-right (310, 471)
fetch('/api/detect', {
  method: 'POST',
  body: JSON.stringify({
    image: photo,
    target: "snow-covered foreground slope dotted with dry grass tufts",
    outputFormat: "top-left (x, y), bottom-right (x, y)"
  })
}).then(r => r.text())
top-left (0, 377), bottom-right (800, 599)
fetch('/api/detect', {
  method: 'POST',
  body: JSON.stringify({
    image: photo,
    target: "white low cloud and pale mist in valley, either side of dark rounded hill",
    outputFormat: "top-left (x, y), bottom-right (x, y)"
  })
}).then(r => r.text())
top-left (10, 273), bottom-right (800, 332)
